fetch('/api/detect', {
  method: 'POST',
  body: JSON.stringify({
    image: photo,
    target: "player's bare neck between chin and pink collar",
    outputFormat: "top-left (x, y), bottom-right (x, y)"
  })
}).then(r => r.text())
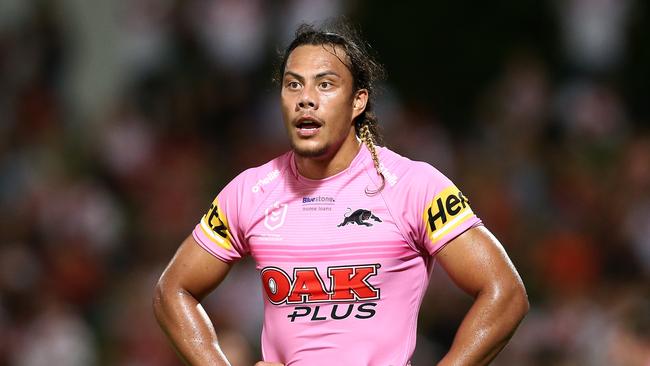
top-left (294, 130), bottom-right (361, 179)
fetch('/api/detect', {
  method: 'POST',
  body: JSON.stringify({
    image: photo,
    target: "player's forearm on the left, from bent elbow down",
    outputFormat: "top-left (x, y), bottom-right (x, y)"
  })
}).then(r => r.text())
top-left (154, 290), bottom-right (230, 366)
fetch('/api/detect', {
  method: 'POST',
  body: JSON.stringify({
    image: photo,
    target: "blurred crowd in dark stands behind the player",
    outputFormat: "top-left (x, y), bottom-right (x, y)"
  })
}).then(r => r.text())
top-left (0, 0), bottom-right (650, 366)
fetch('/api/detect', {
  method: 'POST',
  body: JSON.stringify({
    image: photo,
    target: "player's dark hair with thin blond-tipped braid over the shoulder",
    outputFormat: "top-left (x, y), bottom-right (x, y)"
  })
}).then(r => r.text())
top-left (274, 19), bottom-right (384, 194)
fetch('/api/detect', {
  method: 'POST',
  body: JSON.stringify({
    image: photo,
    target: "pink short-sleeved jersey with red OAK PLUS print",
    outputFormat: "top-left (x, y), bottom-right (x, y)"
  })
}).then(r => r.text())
top-left (193, 147), bottom-right (480, 366)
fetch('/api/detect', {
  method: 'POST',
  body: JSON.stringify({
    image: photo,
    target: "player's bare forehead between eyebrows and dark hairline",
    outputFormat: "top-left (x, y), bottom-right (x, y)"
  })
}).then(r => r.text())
top-left (284, 44), bottom-right (351, 77)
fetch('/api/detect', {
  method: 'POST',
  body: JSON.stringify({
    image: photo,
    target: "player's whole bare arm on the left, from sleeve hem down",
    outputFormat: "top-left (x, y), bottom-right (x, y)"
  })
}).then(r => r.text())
top-left (153, 236), bottom-right (230, 366)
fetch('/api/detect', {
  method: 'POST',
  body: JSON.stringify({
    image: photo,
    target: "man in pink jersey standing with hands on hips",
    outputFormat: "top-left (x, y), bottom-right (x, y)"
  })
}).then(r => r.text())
top-left (154, 21), bottom-right (528, 366)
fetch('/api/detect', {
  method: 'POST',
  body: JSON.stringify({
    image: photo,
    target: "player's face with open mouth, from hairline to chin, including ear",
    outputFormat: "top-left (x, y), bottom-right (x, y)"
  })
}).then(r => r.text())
top-left (281, 45), bottom-right (368, 158)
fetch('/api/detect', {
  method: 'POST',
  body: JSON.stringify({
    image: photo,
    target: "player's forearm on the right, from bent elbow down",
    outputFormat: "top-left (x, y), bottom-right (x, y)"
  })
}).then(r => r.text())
top-left (438, 289), bottom-right (528, 366)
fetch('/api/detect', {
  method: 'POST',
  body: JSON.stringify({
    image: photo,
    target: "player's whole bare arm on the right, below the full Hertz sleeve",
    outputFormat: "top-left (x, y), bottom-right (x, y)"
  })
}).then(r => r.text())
top-left (437, 227), bottom-right (529, 366)
